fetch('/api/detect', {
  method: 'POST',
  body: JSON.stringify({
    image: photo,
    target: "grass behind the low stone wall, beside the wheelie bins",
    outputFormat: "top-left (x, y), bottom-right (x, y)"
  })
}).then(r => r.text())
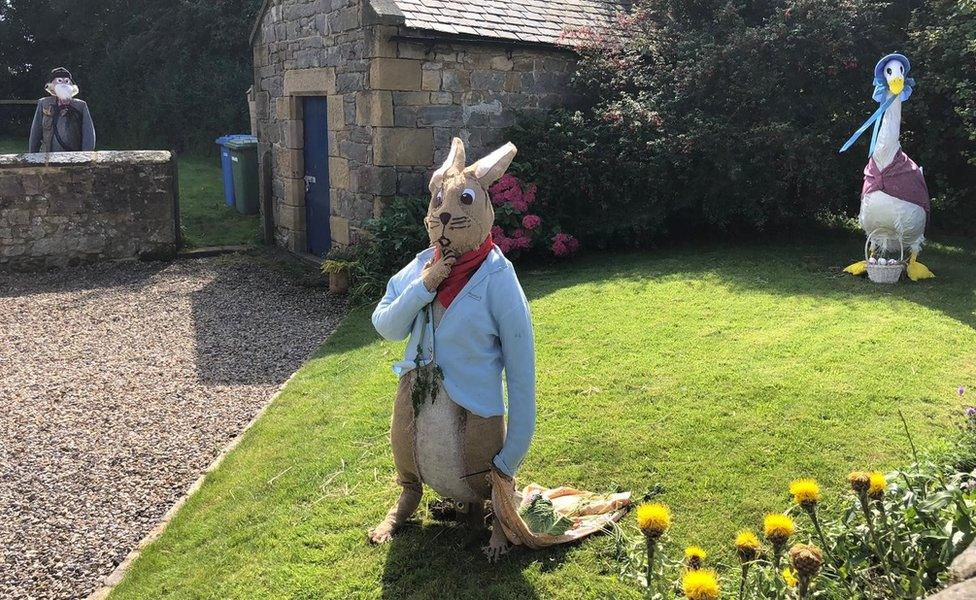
top-left (0, 136), bottom-right (261, 247)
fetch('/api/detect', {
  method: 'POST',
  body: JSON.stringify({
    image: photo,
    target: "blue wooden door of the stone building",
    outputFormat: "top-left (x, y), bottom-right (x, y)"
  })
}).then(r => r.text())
top-left (304, 96), bottom-right (332, 256)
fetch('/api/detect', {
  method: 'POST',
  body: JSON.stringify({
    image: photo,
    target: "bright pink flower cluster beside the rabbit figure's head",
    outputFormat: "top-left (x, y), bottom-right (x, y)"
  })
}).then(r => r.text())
top-left (488, 174), bottom-right (579, 257)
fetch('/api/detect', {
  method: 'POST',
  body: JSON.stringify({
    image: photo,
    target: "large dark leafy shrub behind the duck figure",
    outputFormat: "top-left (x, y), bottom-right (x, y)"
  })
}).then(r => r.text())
top-left (511, 0), bottom-right (976, 246)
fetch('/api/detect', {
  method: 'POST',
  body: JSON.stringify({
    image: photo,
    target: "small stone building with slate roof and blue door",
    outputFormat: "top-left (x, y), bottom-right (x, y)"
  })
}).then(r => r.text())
top-left (249, 0), bottom-right (622, 255)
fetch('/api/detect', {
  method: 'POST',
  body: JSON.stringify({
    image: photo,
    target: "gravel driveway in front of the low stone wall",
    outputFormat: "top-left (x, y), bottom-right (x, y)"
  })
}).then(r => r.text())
top-left (0, 258), bottom-right (343, 599)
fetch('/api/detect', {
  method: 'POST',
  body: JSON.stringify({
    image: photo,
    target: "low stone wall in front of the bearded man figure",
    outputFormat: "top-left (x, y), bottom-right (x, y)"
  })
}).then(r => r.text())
top-left (0, 151), bottom-right (179, 270)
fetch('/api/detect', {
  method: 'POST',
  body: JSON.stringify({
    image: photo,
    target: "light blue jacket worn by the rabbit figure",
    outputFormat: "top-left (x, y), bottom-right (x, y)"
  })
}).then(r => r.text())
top-left (373, 248), bottom-right (535, 477)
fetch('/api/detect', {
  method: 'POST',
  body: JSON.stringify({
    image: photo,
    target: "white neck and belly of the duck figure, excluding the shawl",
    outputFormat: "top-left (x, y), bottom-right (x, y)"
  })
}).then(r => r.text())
top-left (858, 97), bottom-right (926, 254)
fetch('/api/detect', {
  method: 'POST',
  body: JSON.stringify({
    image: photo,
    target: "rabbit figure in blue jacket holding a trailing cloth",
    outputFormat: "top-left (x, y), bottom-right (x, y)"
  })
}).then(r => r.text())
top-left (369, 138), bottom-right (629, 561)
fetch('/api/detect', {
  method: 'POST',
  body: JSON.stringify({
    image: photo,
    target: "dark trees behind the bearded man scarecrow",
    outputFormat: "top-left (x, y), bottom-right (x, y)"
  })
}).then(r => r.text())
top-left (0, 0), bottom-right (260, 150)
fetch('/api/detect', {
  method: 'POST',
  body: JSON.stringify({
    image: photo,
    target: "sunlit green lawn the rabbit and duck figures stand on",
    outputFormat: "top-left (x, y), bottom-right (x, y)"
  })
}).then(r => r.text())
top-left (113, 239), bottom-right (976, 600)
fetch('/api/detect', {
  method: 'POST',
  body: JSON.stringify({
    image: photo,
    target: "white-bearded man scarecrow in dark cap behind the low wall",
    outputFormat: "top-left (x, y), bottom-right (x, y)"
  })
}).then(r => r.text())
top-left (28, 67), bottom-right (95, 152)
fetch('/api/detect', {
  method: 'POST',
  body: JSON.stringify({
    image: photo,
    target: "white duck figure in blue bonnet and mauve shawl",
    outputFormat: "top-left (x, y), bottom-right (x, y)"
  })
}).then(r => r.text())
top-left (840, 54), bottom-right (935, 282)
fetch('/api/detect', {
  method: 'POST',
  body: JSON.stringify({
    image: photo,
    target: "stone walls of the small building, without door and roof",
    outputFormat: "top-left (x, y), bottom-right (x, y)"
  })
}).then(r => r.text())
top-left (251, 0), bottom-right (575, 253)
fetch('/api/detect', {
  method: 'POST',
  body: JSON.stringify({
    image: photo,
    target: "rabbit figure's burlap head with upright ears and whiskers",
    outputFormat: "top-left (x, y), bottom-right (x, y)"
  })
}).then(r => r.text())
top-left (425, 138), bottom-right (517, 256)
